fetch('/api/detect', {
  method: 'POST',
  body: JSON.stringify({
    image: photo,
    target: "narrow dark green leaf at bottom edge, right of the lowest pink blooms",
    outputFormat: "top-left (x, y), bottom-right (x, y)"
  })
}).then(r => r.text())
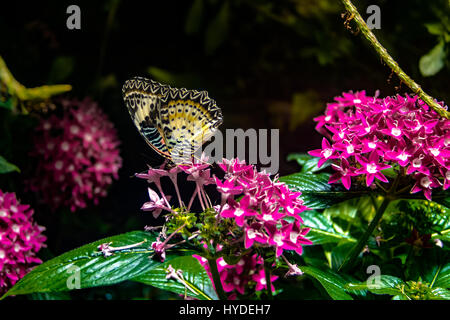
top-left (300, 266), bottom-right (353, 300)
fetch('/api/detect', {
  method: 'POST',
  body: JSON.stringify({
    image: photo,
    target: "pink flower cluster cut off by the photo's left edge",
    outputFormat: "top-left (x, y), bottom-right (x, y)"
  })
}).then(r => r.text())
top-left (0, 190), bottom-right (46, 296)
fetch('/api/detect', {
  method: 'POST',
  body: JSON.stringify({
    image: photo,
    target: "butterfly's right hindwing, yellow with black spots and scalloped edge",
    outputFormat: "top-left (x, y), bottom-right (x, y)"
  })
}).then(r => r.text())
top-left (157, 88), bottom-right (222, 164)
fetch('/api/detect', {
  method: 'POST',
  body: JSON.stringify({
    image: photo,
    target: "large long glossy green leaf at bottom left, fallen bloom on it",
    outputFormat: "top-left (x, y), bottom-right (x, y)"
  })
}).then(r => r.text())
top-left (2, 231), bottom-right (193, 298)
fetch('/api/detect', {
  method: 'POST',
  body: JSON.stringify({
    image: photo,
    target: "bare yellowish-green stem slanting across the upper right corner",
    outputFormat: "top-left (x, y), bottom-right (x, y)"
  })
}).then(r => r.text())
top-left (341, 0), bottom-right (450, 119)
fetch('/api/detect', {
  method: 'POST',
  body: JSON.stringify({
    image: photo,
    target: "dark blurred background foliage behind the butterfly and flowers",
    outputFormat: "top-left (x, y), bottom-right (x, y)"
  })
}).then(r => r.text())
top-left (0, 0), bottom-right (450, 299)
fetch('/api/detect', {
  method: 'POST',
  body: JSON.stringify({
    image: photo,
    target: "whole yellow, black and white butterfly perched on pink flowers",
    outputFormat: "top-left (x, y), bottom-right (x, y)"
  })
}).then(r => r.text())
top-left (122, 77), bottom-right (223, 164)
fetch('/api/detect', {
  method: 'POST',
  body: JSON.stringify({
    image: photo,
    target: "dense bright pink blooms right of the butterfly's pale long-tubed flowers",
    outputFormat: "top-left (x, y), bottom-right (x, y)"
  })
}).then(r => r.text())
top-left (215, 159), bottom-right (312, 257)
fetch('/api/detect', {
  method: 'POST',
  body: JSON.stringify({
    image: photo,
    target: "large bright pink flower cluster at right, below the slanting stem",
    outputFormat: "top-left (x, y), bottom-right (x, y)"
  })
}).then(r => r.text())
top-left (309, 91), bottom-right (450, 200)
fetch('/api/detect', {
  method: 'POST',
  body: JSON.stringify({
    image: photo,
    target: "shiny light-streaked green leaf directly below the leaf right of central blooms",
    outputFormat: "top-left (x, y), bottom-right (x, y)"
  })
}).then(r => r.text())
top-left (301, 210), bottom-right (356, 245)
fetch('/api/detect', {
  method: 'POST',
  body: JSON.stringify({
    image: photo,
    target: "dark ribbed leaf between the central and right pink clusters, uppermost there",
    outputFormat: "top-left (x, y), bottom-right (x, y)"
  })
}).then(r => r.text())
top-left (280, 173), bottom-right (367, 209)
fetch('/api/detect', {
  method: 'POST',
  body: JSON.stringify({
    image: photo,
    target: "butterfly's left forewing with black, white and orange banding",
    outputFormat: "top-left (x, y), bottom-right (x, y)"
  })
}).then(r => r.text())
top-left (122, 77), bottom-right (171, 159)
